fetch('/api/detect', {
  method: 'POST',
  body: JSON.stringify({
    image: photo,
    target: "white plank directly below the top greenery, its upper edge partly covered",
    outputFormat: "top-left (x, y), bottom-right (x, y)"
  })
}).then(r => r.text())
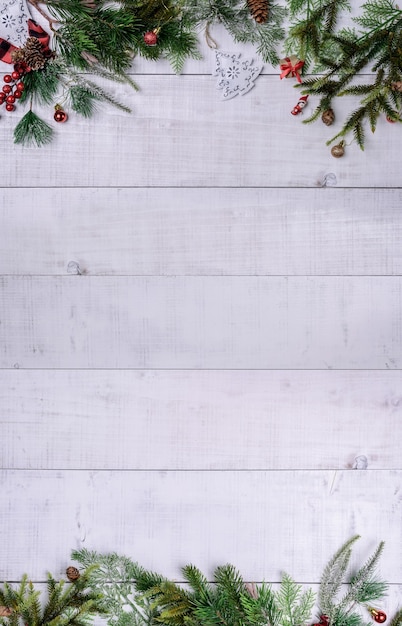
top-left (1, 76), bottom-right (402, 186)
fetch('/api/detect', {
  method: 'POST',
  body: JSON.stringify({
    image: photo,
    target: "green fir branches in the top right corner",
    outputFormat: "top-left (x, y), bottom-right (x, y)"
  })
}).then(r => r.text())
top-left (286, 0), bottom-right (402, 150)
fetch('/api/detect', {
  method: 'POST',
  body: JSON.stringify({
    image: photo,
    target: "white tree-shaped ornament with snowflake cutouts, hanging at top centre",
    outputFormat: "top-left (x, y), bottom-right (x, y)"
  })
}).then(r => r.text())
top-left (214, 51), bottom-right (263, 100)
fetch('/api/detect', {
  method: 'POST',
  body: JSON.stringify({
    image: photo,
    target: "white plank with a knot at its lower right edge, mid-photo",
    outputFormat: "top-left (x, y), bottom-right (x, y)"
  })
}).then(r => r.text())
top-left (0, 370), bottom-right (402, 470)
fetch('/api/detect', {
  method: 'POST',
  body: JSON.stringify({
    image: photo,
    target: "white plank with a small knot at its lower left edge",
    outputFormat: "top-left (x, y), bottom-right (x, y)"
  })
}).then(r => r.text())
top-left (0, 188), bottom-right (402, 275)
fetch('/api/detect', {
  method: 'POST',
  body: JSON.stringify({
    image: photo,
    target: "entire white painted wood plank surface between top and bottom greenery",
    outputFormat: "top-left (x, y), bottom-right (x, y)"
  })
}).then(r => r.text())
top-left (0, 0), bottom-right (402, 614)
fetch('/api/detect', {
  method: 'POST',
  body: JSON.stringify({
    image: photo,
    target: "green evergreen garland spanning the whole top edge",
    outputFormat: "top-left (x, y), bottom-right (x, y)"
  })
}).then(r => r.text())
top-left (2, 0), bottom-right (402, 149)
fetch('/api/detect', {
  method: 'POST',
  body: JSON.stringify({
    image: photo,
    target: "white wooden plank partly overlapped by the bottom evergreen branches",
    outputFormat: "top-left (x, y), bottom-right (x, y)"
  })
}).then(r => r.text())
top-left (0, 470), bottom-right (402, 582)
